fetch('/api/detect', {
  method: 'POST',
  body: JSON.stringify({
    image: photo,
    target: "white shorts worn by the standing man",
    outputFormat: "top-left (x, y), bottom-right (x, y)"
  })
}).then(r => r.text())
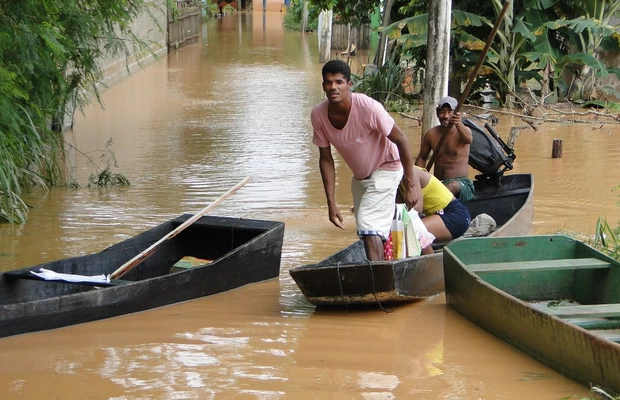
top-left (351, 169), bottom-right (403, 240)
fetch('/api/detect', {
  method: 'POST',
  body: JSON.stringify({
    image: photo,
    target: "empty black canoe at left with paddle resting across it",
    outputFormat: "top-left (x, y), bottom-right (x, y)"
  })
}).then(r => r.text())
top-left (0, 215), bottom-right (284, 337)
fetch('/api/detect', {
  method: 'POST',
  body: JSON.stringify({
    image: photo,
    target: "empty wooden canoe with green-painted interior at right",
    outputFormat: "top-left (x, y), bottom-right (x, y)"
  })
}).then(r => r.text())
top-left (444, 235), bottom-right (620, 394)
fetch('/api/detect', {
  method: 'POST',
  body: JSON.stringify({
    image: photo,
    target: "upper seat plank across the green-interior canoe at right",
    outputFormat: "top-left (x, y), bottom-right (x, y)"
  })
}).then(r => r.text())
top-left (467, 258), bottom-right (611, 273)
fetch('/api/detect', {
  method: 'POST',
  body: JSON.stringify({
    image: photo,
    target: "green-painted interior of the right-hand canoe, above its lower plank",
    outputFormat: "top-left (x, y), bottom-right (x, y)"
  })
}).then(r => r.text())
top-left (449, 235), bottom-right (620, 304)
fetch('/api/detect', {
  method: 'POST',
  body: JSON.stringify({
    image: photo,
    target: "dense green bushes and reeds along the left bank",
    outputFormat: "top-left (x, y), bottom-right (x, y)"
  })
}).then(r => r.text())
top-left (0, 0), bottom-right (156, 223)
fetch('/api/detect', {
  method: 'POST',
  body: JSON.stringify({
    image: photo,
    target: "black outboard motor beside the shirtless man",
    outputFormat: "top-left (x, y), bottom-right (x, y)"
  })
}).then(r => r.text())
top-left (463, 118), bottom-right (516, 179)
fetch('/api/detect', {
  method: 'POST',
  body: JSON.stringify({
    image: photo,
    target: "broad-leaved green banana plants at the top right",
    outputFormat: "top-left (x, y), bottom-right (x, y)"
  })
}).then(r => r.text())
top-left (385, 0), bottom-right (620, 105)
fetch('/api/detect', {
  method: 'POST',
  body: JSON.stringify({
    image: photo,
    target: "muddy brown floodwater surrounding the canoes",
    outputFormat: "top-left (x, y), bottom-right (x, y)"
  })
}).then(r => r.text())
top-left (0, 12), bottom-right (620, 399)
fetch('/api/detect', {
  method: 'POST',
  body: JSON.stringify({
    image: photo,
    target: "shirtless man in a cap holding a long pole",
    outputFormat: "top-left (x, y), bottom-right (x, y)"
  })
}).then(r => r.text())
top-left (415, 97), bottom-right (474, 203)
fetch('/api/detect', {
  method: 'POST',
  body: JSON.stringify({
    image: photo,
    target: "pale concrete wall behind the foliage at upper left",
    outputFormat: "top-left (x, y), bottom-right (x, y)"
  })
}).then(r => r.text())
top-left (99, 0), bottom-right (168, 89)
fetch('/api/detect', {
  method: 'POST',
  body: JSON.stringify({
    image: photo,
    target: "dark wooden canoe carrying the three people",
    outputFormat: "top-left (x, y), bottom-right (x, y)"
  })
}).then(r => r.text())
top-left (289, 174), bottom-right (534, 306)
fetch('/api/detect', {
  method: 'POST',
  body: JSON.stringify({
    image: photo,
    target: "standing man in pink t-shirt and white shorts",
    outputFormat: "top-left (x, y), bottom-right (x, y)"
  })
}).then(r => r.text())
top-left (311, 60), bottom-right (421, 261)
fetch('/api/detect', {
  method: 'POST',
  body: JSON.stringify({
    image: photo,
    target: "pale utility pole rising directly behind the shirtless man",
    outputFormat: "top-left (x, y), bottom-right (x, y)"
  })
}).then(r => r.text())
top-left (422, 0), bottom-right (452, 139)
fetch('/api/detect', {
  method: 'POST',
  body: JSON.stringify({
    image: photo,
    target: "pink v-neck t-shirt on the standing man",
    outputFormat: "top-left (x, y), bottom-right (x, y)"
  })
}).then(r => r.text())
top-left (311, 93), bottom-right (402, 179)
